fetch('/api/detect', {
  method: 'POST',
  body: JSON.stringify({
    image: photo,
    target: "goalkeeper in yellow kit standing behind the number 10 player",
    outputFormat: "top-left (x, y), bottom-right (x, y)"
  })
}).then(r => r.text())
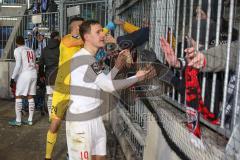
top-left (45, 17), bottom-right (84, 160)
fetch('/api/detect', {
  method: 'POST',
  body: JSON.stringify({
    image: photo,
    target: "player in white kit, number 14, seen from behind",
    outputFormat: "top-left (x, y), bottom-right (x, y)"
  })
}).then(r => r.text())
top-left (9, 36), bottom-right (37, 126)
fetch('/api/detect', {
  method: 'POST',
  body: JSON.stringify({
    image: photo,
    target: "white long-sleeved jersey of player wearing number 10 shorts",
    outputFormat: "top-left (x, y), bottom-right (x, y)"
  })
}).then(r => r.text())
top-left (69, 48), bottom-right (138, 114)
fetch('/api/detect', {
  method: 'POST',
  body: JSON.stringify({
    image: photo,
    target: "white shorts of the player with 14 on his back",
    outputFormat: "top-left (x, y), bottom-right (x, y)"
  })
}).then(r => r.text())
top-left (16, 72), bottom-right (37, 96)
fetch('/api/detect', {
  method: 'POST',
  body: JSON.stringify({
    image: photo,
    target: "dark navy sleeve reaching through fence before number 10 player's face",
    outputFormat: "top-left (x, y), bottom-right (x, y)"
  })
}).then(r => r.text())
top-left (117, 27), bottom-right (149, 49)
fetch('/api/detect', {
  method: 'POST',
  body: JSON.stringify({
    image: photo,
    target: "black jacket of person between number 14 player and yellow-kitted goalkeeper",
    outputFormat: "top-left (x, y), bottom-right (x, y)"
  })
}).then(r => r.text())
top-left (39, 39), bottom-right (60, 85)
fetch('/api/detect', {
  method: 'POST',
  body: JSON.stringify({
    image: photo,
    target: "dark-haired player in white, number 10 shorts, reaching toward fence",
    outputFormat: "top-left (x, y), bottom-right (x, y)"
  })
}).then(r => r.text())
top-left (66, 20), bottom-right (155, 160)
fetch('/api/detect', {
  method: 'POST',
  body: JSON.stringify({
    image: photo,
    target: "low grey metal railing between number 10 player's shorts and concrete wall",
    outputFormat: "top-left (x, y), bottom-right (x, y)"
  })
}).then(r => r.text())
top-left (115, 100), bottom-right (146, 159)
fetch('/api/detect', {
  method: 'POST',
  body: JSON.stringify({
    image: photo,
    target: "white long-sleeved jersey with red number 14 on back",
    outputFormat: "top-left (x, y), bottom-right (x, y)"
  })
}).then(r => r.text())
top-left (12, 46), bottom-right (36, 79)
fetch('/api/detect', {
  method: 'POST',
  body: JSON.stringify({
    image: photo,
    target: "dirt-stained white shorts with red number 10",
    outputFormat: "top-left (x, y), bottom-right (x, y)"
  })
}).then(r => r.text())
top-left (66, 117), bottom-right (106, 160)
